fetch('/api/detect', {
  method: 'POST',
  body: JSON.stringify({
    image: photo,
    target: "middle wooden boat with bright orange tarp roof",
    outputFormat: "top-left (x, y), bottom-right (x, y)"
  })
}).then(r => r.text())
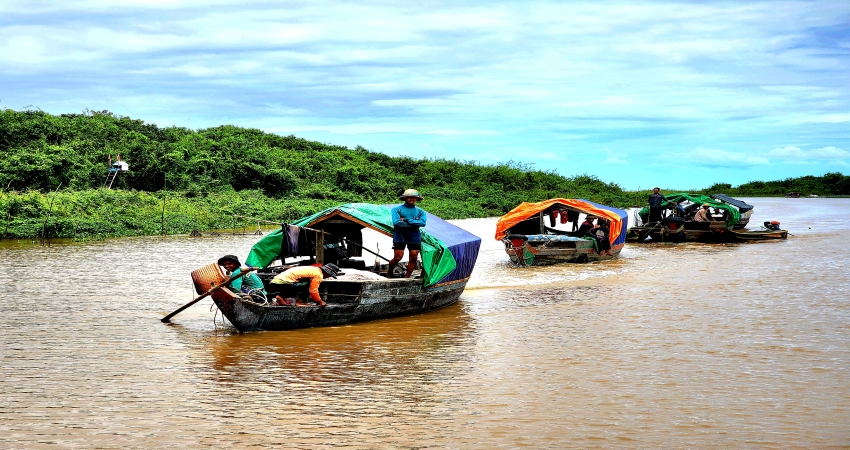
top-left (496, 198), bottom-right (629, 267)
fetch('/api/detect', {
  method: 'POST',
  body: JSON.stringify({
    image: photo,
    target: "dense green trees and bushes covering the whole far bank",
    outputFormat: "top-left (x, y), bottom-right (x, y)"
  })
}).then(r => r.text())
top-left (0, 109), bottom-right (850, 239)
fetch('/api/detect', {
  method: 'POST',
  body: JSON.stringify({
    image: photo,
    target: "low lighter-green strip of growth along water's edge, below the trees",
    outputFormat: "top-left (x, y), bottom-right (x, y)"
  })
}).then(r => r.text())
top-left (0, 189), bottom-right (836, 240)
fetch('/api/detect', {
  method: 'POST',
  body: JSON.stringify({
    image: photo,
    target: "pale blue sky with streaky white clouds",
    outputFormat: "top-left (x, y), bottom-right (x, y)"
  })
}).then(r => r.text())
top-left (0, 0), bottom-right (850, 189)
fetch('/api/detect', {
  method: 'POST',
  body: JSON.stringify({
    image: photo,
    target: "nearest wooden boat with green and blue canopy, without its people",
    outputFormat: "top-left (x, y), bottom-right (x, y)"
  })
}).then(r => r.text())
top-left (192, 203), bottom-right (481, 331)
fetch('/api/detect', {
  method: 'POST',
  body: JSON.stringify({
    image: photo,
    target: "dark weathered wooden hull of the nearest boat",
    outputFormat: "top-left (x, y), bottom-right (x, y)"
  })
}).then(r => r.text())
top-left (212, 279), bottom-right (468, 331)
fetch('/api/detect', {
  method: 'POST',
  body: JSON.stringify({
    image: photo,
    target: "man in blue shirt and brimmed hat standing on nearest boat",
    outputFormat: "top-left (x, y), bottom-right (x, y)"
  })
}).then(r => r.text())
top-left (387, 189), bottom-right (425, 278)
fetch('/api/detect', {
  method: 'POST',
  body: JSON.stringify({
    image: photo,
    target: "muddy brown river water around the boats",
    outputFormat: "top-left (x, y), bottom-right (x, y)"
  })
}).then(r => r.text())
top-left (0, 199), bottom-right (850, 448)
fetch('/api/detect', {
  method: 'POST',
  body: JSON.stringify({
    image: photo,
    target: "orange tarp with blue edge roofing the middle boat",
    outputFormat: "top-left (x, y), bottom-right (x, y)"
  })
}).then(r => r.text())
top-left (496, 198), bottom-right (629, 245)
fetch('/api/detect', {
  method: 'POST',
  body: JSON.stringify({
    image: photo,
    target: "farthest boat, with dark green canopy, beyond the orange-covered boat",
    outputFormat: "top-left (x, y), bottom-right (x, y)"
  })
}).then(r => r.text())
top-left (626, 193), bottom-right (788, 243)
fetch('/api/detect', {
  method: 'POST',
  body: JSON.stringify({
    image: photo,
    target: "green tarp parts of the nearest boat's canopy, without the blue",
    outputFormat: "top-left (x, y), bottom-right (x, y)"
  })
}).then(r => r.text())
top-left (245, 203), bottom-right (457, 286)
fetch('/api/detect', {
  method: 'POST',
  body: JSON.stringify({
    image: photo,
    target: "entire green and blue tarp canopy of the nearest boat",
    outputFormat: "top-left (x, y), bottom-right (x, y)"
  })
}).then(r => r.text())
top-left (245, 203), bottom-right (481, 286)
